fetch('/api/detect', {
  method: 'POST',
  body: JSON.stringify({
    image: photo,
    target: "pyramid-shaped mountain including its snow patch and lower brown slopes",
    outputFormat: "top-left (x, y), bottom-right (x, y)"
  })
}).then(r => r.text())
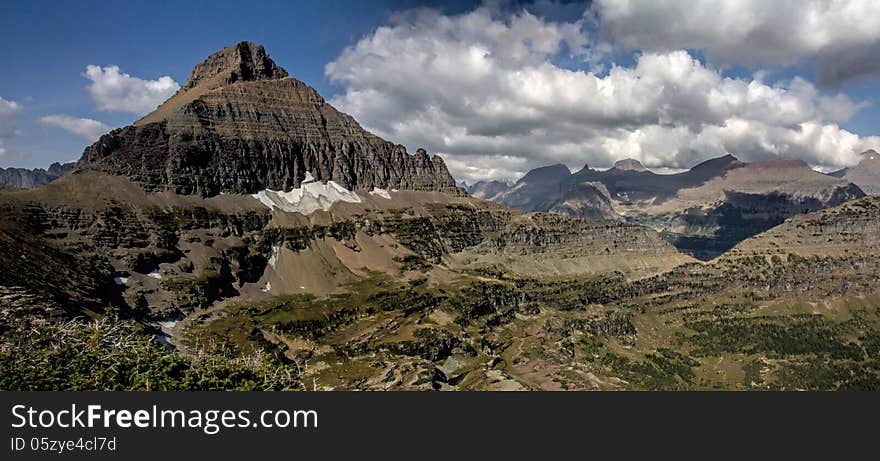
top-left (0, 42), bottom-right (690, 328)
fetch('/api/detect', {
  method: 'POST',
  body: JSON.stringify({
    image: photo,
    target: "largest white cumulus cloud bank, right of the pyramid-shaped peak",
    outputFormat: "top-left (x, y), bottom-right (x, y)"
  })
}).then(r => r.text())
top-left (325, 8), bottom-right (880, 182)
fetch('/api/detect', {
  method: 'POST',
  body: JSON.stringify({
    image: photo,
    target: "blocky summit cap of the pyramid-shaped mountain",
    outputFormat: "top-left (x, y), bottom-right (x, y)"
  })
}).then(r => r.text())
top-left (181, 42), bottom-right (288, 91)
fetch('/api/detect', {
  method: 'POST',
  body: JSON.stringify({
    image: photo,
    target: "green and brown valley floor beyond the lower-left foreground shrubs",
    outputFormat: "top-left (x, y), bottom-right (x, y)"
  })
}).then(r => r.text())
top-left (172, 252), bottom-right (880, 390)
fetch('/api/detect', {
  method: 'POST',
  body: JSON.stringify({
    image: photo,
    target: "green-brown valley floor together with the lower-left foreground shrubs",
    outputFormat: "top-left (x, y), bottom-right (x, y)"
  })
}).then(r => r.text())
top-left (0, 250), bottom-right (880, 390)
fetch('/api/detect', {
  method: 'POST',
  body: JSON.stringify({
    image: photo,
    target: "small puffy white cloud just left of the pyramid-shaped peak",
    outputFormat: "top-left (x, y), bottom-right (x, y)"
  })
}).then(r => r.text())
top-left (83, 65), bottom-right (180, 115)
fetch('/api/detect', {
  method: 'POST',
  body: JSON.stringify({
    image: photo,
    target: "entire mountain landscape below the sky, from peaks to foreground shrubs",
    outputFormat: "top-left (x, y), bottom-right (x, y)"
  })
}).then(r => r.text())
top-left (0, 43), bottom-right (880, 390)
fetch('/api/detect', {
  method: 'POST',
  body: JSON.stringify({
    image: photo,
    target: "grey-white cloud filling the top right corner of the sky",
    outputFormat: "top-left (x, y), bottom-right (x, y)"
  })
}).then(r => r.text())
top-left (593, 0), bottom-right (880, 85)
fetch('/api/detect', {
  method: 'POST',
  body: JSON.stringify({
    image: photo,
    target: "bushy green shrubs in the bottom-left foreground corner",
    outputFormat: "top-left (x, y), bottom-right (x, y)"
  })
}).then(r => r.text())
top-left (0, 320), bottom-right (298, 391)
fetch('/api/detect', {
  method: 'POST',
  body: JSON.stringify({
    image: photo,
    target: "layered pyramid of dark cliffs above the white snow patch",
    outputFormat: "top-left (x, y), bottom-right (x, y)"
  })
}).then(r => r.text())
top-left (80, 42), bottom-right (456, 196)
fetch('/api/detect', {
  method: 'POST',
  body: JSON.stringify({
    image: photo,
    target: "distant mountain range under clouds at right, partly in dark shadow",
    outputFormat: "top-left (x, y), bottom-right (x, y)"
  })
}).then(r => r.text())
top-left (470, 155), bottom-right (864, 259)
